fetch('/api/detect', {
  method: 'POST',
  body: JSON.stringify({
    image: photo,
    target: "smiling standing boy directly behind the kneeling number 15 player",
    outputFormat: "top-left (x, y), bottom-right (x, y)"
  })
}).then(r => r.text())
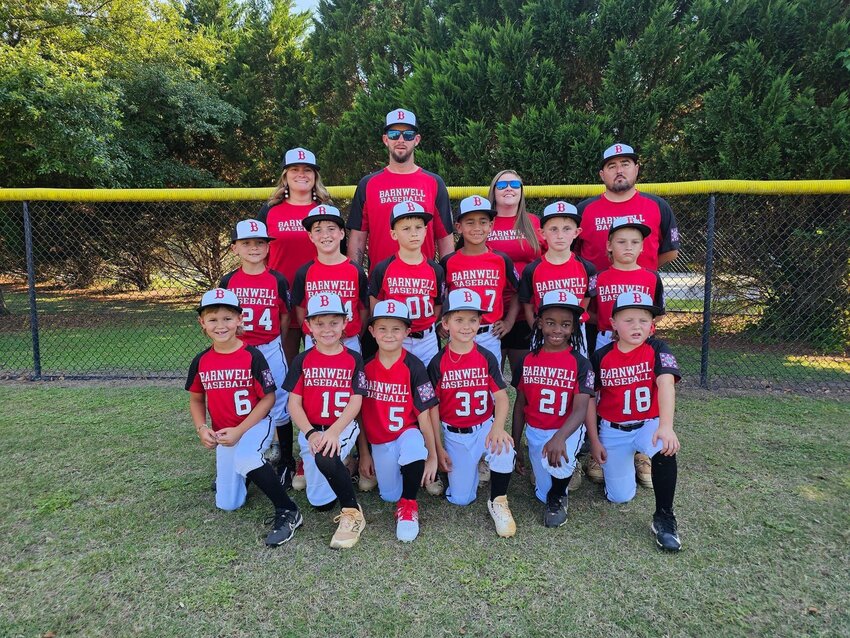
top-left (292, 204), bottom-right (369, 352)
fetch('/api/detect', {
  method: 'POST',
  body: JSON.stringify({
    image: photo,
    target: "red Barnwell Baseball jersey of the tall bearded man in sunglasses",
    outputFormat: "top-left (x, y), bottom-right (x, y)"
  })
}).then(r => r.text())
top-left (347, 168), bottom-right (454, 270)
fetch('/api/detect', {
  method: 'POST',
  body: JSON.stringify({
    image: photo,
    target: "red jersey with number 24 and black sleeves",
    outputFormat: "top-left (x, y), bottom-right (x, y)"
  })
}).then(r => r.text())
top-left (218, 268), bottom-right (290, 346)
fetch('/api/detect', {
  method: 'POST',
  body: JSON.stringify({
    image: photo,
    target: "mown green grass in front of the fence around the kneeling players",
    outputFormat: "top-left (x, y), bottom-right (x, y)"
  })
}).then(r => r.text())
top-left (0, 383), bottom-right (850, 638)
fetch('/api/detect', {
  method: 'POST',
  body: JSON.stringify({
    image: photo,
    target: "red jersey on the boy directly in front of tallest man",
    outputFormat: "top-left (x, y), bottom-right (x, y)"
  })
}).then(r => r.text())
top-left (369, 255), bottom-right (446, 332)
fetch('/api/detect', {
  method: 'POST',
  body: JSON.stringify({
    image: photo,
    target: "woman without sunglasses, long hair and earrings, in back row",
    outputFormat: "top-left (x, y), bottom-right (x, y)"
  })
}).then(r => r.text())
top-left (257, 148), bottom-right (331, 364)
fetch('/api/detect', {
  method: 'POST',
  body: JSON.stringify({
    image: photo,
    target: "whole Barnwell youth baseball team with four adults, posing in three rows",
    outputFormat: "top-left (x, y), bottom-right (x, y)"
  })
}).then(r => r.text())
top-left (186, 109), bottom-right (681, 551)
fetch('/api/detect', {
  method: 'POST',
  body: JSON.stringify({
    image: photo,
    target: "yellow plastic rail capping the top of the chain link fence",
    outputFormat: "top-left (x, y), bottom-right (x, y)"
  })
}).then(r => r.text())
top-left (0, 179), bottom-right (850, 202)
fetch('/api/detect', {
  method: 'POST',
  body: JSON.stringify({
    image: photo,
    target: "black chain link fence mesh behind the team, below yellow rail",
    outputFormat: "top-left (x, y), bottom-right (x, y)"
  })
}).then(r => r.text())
top-left (0, 191), bottom-right (850, 393)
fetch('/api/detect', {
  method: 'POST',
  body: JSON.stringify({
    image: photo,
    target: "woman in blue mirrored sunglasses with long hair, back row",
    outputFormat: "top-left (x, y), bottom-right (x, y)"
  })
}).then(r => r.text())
top-left (487, 169), bottom-right (542, 370)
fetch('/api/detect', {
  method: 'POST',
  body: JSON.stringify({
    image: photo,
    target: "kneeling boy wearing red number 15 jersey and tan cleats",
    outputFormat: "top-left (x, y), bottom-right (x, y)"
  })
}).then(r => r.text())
top-left (283, 292), bottom-right (366, 549)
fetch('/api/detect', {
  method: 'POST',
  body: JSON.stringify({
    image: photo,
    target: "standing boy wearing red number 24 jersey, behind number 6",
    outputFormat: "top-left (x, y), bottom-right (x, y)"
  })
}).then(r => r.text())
top-left (218, 219), bottom-right (295, 487)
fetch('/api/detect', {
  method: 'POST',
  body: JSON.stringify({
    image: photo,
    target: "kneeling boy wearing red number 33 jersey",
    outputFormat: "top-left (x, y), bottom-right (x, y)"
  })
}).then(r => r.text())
top-left (428, 288), bottom-right (516, 538)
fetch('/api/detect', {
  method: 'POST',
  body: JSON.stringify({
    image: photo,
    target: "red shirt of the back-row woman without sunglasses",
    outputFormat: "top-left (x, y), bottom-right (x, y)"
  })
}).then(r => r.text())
top-left (257, 200), bottom-right (317, 281)
